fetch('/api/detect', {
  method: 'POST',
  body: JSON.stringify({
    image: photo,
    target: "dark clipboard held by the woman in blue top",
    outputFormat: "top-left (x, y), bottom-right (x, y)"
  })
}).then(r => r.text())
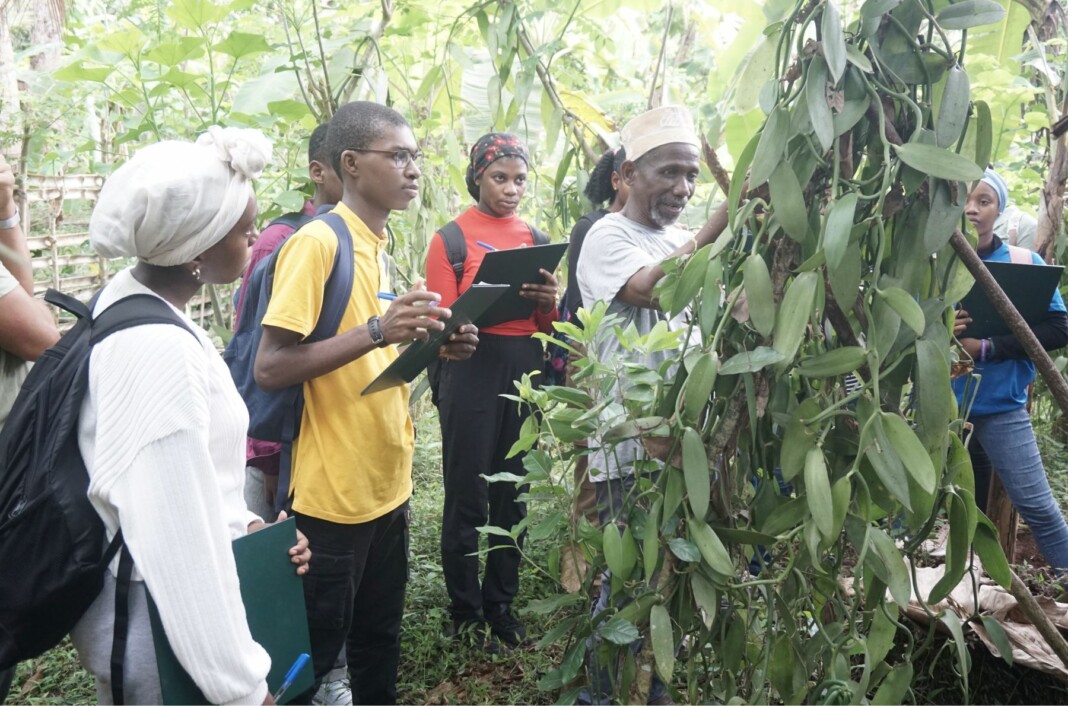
top-left (957, 262), bottom-right (1065, 339)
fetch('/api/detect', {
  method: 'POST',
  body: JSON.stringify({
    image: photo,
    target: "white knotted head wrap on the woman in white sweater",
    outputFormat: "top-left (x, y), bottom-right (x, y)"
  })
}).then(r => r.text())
top-left (89, 125), bottom-right (271, 267)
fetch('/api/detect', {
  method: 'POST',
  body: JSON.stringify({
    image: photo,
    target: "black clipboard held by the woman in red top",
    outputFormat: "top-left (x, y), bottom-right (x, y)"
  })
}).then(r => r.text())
top-left (473, 242), bottom-right (567, 328)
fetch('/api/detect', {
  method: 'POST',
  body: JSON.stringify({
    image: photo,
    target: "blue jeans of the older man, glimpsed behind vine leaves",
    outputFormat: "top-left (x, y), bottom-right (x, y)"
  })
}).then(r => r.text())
top-left (577, 475), bottom-right (668, 704)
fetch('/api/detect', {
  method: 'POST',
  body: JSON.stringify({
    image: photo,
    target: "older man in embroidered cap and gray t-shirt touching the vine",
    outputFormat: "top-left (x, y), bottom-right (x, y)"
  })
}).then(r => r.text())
top-left (578, 106), bottom-right (726, 704)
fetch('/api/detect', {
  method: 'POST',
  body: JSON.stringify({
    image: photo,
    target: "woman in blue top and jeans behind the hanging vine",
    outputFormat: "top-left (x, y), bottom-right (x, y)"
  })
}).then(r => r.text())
top-left (953, 169), bottom-right (1068, 575)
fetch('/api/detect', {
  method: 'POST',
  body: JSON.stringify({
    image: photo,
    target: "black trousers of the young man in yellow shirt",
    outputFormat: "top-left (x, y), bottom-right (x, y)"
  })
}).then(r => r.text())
top-left (294, 502), bottom-right (409, 704)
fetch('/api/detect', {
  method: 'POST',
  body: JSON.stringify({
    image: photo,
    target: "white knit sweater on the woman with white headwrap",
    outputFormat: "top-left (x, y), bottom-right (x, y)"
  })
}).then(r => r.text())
top-left (78, 269), bottom-right (270, 704)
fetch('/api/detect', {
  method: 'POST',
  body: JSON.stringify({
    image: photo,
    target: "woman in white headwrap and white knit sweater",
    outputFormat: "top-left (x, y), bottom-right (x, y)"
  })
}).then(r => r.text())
top-left (72, 127), bottom-right (309, 703)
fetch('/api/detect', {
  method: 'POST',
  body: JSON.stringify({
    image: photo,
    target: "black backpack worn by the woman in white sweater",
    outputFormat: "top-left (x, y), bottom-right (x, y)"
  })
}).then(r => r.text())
top-left (0, 289), bottom-right (195, 703)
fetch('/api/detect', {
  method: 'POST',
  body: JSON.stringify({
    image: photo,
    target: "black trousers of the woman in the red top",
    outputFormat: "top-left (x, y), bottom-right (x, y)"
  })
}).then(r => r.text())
top-left (438, 333), bottom-right (543, 621)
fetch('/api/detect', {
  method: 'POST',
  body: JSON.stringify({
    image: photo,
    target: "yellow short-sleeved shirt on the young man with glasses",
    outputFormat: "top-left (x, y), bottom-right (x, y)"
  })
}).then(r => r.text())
top-left (263, 204), bottom-right (414, 524)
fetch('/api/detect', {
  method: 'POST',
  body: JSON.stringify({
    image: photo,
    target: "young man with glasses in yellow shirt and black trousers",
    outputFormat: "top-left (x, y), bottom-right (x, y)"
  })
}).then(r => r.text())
top-left (255, 101), bottom-right (478, 704)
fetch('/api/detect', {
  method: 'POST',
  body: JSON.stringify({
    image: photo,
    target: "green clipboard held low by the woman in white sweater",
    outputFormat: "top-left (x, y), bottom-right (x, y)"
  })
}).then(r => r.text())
top-left (148, 517), bottom-right (315, 704)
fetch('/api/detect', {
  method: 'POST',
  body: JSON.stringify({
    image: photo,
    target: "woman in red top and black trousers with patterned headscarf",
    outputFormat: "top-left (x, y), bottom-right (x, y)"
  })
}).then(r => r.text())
top-left (426, 132), bottom-right (559, 652)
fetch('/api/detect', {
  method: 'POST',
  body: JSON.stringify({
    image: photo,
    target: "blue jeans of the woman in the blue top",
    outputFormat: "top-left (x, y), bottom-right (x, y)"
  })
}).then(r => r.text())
top-left (971, 407), bottom-right (1068, 572)
